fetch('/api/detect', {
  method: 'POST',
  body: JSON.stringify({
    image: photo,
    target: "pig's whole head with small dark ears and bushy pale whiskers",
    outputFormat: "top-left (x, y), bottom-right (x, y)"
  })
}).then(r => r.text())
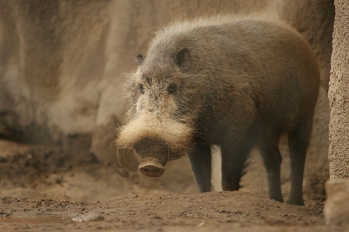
top-left (117, 44), bottom-right (200, 177)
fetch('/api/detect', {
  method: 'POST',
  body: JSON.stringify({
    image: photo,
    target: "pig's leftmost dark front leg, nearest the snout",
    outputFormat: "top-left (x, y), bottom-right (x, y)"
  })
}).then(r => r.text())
top-left (188, 143), bottom-right (211, 192)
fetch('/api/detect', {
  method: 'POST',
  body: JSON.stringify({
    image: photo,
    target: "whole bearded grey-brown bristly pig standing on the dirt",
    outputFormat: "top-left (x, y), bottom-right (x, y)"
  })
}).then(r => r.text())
top-left (117, 14), bottom-right (319, 205)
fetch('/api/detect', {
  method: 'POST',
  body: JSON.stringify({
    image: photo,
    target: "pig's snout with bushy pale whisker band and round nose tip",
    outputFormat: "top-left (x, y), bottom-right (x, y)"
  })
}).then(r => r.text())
top-left (118, 116), bottom-right (193, 177)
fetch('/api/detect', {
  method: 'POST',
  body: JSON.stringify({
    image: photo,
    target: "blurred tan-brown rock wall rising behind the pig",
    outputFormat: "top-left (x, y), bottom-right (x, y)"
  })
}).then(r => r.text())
top-left (0, 0), bottom-right (334, 196)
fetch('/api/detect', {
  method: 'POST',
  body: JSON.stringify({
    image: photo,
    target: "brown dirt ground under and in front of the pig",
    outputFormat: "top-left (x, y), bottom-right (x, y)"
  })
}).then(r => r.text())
top-left (0, 140), bottom-right (349, 231)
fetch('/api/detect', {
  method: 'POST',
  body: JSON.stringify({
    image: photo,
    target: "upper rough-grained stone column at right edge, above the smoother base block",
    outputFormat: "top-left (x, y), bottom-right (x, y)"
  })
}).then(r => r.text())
top-left (328, 0), bottom-right (349, 180)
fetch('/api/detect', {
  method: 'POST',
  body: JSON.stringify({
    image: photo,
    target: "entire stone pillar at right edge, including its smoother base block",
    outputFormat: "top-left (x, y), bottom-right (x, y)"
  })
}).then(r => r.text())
top-left (324, 0), bottom-right (349, 224)
